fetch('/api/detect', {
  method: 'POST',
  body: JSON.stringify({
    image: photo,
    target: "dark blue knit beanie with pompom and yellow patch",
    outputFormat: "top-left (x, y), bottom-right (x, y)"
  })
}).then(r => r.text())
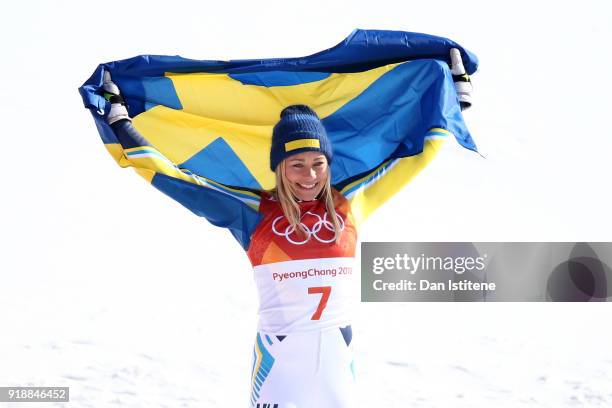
top-left (270, 105), bottom-right (333, 171)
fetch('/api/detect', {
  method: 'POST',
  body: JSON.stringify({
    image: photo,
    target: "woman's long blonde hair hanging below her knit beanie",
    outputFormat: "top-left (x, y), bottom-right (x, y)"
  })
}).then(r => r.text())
top-left (270, 160), bottom-right (340, 243)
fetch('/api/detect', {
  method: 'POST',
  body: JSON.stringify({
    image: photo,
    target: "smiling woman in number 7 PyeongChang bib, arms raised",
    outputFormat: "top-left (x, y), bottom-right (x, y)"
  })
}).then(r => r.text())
top-left (103, 45), bottom-right (471, 408)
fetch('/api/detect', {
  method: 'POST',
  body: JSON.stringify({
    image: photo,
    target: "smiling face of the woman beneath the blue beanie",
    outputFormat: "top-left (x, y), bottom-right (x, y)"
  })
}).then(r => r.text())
top-left (284, 152), bottom-right (329, 201)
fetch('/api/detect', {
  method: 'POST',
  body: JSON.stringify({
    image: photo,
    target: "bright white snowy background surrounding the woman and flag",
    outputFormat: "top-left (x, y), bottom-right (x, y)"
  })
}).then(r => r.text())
top-left (0, 0), bottom-right (612, 408)
